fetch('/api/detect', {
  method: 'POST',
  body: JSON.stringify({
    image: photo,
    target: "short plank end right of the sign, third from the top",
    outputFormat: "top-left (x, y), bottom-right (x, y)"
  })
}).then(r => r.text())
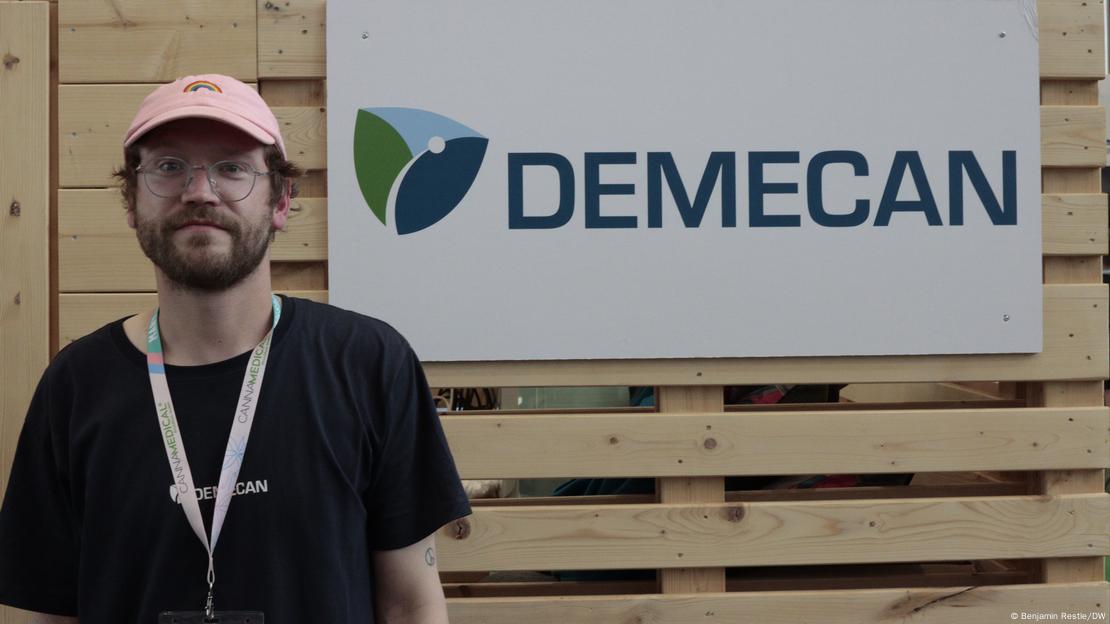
top-left (1041, 193), bottom-right (1110, 255)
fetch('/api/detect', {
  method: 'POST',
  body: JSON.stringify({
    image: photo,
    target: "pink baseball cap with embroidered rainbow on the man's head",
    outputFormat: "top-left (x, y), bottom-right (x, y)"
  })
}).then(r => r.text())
top-left (123, 73), bottom-right (285, 155)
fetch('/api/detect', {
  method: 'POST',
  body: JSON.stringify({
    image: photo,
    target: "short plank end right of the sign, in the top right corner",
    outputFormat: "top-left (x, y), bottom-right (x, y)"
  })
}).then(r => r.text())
top-left (1032, 0), bottom-right (1106, 80)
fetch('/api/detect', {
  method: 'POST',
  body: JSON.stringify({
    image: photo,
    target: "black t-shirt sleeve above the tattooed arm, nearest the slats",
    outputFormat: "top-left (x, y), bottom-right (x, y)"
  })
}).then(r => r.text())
top-left (366, 345), bottom-right (471, 551)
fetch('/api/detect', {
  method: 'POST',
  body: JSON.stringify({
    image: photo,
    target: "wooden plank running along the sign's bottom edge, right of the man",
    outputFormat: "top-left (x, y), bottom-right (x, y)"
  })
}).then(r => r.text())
top-left (424, 284), bottom-right (1110, 388)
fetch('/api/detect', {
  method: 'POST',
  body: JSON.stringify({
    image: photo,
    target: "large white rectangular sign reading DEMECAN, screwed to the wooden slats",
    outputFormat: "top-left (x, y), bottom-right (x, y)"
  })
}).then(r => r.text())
top-left (327, 0), bottom-right (1042, 361)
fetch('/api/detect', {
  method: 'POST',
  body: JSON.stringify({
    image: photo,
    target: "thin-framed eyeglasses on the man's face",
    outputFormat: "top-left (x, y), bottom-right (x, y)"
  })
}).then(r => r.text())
top-left (135, 157), bottom-right (273, 202)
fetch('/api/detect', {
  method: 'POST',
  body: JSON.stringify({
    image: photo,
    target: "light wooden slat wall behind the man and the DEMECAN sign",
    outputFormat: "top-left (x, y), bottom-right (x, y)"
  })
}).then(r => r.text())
top-left (0, 0), bottom-right (1096, 624)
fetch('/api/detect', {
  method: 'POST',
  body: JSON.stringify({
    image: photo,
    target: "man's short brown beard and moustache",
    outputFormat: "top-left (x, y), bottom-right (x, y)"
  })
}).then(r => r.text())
top-left (135, 207), bottom-right (273, 292)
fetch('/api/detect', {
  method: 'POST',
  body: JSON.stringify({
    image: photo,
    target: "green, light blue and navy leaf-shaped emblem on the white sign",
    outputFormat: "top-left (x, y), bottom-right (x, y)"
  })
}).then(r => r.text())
top-left (354, 108), bottom-right (490, 234)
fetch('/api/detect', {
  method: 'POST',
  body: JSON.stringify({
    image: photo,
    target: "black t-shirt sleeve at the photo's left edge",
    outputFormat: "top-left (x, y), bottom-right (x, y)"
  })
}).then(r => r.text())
top-left (0, 373), bottom-right (78, 615)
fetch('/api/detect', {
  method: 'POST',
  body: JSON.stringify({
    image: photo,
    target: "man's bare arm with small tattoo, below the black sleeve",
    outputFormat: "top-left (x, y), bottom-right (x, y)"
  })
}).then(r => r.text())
top-left (371, 534), bottom-right (447, 624)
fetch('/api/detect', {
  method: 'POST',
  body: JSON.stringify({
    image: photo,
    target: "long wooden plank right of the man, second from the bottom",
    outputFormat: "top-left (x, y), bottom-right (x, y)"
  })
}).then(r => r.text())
top-left (437, 493), bottom-right (1110, 572)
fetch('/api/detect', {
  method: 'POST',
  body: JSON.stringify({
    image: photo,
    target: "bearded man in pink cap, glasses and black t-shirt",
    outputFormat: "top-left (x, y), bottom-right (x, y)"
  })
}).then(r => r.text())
top-left (0, 76), bottom-right (470, 624)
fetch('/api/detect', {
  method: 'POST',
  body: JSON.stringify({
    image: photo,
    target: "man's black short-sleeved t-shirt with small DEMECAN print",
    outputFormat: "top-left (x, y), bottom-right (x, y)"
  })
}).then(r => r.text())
top-left (0, 298), bottom-right (470, 624)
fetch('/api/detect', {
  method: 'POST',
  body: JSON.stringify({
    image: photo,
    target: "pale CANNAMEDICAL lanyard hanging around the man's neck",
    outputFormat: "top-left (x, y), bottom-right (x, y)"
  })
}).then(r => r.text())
top-left (147, 294), bottom-right (281, 616)
